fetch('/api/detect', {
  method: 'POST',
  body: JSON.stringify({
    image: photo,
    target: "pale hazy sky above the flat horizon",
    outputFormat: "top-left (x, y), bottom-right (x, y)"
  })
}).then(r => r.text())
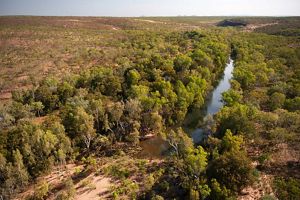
top-left (0, 0), bottom-right (300, 16)
